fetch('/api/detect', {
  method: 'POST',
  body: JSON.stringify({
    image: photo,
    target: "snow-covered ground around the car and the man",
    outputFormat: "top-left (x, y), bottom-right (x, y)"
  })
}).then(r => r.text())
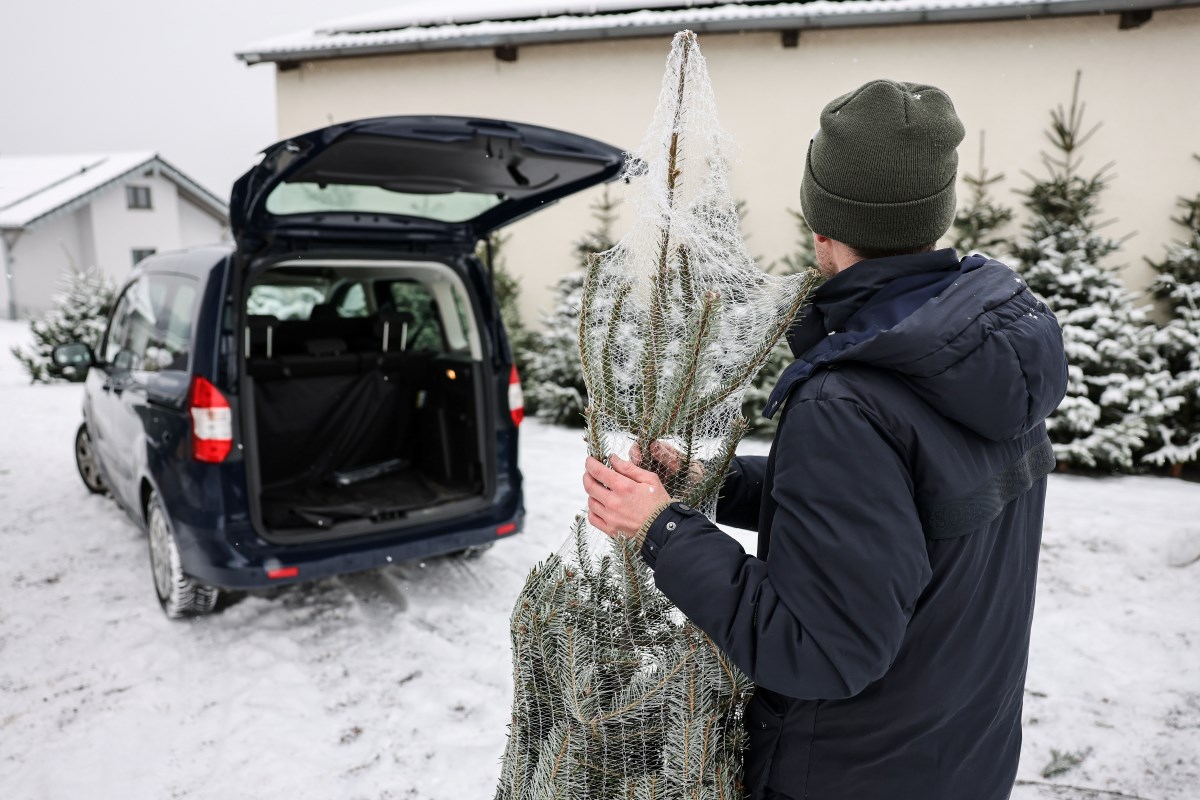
top-left (0, 323), bottom-right (1200, 800)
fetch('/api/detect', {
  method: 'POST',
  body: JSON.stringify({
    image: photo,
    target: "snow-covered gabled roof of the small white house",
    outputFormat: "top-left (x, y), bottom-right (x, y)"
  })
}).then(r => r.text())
top-left (0, 151), bottom-right (229, 229)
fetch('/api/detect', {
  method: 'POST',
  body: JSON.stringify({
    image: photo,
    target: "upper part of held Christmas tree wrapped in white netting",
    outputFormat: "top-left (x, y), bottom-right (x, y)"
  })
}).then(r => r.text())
top-left (580, 32), bottom-right (811, 513)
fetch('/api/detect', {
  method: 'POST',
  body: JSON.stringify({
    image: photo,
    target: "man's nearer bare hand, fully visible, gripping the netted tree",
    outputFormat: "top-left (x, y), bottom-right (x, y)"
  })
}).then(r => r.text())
top-left (583, 456), bottom-right (671, 537)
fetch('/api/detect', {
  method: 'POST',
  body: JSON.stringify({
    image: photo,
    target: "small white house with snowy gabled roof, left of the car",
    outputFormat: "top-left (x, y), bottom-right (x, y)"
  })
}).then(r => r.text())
top-left (0, 152), bottom-right (229, 319)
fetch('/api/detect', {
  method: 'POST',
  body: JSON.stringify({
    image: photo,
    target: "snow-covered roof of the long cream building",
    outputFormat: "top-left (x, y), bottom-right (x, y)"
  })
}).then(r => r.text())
top-left (236, 0), bottom-right (1180, 64)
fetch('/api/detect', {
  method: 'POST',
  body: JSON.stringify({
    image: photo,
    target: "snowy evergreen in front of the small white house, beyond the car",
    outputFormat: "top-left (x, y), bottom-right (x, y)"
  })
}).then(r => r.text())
top-left (12, 266), bottom-right (116, 383)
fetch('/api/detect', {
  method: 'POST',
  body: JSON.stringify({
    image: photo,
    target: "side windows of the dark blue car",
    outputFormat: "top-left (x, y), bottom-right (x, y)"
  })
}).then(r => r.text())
top-left (102, 275), bottom-right (196, 372)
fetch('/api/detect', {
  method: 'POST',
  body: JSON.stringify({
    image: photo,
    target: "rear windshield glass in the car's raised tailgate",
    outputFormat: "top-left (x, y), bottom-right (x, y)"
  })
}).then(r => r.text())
top-left (266, 182), bottom-right (500, 222)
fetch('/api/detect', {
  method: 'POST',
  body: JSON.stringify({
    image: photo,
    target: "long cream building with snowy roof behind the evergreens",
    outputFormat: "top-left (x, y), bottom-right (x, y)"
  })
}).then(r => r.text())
top-left (238, 0), bottom-right (1200, 323)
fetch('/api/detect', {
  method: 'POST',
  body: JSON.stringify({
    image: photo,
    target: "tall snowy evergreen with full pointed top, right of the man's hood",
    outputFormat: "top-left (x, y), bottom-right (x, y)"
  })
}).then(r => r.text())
top-left (1012, 73), bottom-right (1168, 470)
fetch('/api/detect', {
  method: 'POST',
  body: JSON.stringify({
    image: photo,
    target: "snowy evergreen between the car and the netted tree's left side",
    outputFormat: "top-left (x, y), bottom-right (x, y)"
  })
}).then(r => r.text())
top-left (522, 186), bottom-right (620, 427)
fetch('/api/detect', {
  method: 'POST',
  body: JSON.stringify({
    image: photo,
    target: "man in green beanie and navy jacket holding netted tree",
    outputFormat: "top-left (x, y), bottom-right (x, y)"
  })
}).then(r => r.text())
top-left (584, 80), bottom-right (1067, 800)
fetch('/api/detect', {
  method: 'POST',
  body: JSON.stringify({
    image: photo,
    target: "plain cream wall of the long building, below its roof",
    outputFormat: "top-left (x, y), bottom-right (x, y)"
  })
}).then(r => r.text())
top-left (277, 8), bottom-right (1200, 321)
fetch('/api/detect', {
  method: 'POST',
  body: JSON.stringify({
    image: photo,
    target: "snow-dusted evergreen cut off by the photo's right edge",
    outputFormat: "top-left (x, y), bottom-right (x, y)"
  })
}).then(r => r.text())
top-left (1145, 156), bottom-right (1200, 473)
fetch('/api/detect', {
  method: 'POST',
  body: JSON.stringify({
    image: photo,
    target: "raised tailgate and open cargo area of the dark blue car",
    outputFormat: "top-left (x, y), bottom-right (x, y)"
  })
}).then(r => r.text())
top-left (230, 116), bottom-right (624, 542)
